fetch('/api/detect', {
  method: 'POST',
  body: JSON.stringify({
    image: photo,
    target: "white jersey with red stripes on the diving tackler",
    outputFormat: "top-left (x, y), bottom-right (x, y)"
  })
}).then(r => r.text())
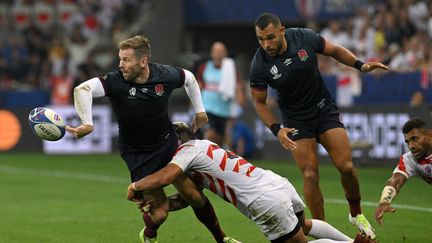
top-left (170, 140), bottom-right (287, 216)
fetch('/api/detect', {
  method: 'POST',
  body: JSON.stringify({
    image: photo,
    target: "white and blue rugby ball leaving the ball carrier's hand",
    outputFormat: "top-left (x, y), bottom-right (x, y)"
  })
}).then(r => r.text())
top-left (29, 107), bottom-right (66, 141)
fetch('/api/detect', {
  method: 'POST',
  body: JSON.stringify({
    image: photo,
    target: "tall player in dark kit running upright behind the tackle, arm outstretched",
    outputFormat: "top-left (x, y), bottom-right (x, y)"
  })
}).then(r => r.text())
top-left (249, 13), bottom-right (388, 239)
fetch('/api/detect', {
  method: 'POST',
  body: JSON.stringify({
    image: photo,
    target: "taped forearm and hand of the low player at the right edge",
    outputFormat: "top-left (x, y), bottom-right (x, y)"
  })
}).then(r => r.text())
top-left (375, 173), bottom-right (407, 225)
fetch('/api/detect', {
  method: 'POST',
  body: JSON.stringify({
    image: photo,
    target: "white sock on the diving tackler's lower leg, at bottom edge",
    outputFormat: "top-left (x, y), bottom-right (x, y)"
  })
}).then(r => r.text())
top-left (309, 219), bottom-right (353, 242)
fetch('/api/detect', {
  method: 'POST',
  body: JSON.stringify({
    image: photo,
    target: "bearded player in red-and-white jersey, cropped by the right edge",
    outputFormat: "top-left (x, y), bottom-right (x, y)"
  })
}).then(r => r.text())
top-left (375, 117), bottom-right (432, 225)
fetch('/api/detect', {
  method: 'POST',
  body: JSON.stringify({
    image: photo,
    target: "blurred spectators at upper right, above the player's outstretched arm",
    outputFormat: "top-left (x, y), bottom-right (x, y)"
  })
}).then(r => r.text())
top-left (316, 0), bottom-right (432, 74)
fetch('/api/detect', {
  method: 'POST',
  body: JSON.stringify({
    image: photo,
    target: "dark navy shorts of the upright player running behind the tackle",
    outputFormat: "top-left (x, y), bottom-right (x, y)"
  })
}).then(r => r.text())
top-left (283, 105), bottom-right (345, 142)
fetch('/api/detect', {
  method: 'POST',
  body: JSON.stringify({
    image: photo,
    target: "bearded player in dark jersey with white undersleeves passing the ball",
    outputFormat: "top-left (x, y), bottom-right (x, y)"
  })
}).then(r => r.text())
top-left (66, 36), bottom-right (236, 242)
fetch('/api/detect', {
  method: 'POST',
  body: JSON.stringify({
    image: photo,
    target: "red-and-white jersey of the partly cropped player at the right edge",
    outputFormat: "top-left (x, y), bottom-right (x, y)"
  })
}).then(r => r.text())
top-left (393, 152), bottom-right (432, 181)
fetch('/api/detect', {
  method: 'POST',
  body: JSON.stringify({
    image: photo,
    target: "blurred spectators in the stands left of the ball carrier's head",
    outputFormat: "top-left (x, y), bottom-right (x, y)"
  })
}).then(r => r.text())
top-left (0, 0), bottom-right (149, 97)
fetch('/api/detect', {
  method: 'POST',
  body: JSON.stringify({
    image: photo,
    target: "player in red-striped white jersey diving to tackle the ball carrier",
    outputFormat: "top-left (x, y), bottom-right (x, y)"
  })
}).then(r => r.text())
top-left (128, 123), bottom-right (370, 242)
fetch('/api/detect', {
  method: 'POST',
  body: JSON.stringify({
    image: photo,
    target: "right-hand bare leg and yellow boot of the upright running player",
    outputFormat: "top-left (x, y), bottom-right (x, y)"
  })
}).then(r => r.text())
top-left (319, 128), bottom-right (375, 239)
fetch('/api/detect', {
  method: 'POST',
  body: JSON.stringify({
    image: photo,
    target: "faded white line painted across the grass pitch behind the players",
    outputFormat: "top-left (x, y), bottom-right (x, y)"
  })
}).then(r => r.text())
top-left (0, 165), bottom-right (432, 213)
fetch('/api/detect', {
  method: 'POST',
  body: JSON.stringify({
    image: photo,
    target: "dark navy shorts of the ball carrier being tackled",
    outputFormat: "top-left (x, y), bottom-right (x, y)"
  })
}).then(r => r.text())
top-left (121, 133), bottom-right (178, 182)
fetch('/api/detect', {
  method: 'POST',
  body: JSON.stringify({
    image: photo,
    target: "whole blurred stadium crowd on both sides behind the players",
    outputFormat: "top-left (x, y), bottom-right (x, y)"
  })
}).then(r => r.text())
top-left (0, 0), bottom-right (432, 104)
